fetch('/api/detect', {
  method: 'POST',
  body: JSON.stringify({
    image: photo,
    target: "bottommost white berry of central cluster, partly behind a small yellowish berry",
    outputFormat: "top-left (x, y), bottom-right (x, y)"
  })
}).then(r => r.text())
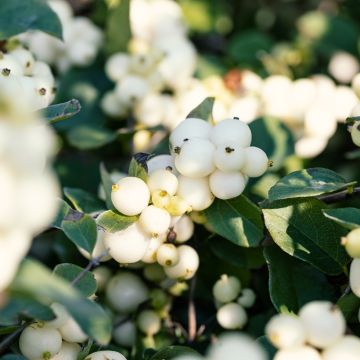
top-left (164, 245), bottom-right (199, 280)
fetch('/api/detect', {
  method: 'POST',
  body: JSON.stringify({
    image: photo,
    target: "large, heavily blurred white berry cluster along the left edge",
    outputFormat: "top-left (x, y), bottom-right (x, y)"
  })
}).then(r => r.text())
top-left (0, 71), bottom-right (60, 291)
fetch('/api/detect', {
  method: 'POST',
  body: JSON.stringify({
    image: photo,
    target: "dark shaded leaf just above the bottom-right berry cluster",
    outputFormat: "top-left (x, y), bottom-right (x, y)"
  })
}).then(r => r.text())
top-left (264, 245), bottom-right (336, 313)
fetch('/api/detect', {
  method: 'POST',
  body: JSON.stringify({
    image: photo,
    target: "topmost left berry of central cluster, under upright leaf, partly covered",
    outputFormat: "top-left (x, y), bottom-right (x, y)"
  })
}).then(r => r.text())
top-left (169, 118), bottom-right (212, 151)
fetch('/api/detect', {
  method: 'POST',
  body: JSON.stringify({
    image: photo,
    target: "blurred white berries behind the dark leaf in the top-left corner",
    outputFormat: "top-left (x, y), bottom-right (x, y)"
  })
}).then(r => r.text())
top-left (20, 0), bottom-right (103, 72)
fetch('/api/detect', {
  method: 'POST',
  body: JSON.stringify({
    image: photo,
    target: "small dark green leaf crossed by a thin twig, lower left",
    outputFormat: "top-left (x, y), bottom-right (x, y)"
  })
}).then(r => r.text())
top-left (54, 263), bottom-right (96, 297)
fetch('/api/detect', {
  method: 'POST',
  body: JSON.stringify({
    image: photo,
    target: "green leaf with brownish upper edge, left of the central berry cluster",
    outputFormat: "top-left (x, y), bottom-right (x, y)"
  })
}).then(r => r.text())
top-left (61, 211), bottom-right (97, 253)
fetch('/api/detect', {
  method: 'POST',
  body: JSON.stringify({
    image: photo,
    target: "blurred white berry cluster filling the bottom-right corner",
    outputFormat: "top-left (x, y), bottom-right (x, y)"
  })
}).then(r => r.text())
top-left (266, 301), bottom-right (360, 360)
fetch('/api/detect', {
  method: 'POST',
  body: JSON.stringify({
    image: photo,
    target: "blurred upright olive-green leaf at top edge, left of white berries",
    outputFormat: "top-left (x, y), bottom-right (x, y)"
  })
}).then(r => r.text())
top-left (105, 0), bottom-right (131, 54)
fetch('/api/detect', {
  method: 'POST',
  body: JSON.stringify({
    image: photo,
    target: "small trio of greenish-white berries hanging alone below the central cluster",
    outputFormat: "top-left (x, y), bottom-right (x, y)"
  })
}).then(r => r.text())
top-left (213, 274), bottom-right (256, 330)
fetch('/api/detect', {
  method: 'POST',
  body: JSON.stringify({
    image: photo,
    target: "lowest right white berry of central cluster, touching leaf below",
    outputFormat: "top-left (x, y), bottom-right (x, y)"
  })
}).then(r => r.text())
top-left (209, 170), bottom-right (246, 200)
